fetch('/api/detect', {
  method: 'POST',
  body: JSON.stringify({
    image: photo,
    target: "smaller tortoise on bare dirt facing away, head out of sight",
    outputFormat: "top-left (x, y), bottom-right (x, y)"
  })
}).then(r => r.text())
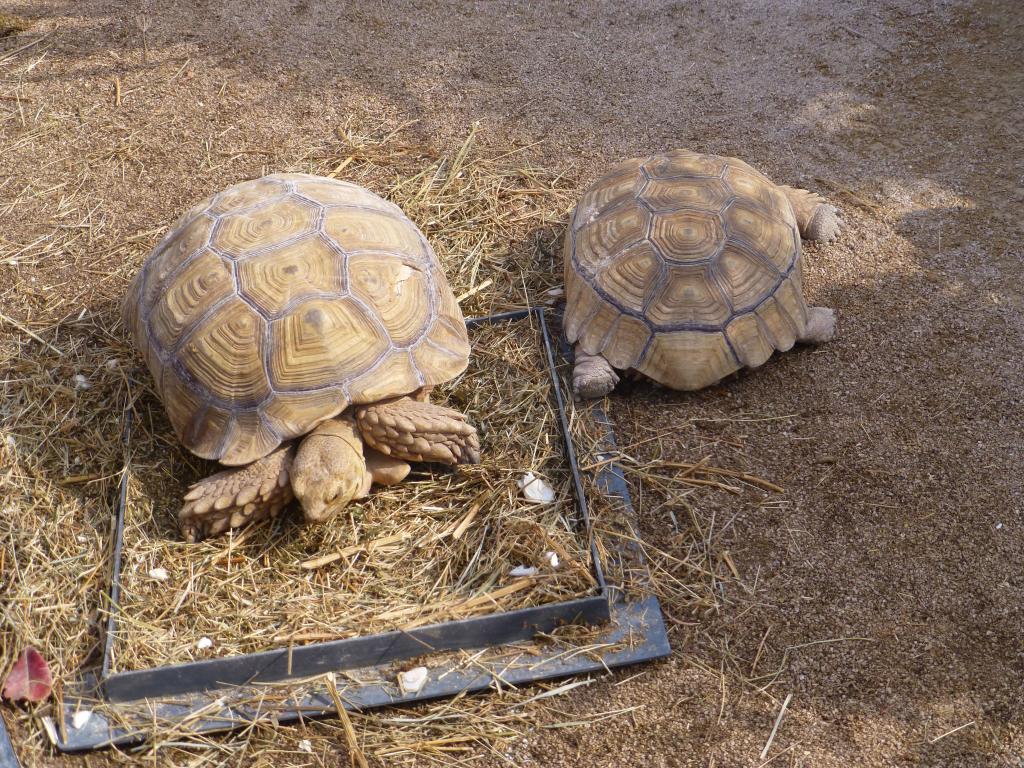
top-left (563, 150), bottom-right (841, 398)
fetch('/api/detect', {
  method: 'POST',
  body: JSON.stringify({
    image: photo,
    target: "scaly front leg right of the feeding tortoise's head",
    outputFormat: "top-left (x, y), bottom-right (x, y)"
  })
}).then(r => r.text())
top-left (355, 397), bottom-right (480, 464)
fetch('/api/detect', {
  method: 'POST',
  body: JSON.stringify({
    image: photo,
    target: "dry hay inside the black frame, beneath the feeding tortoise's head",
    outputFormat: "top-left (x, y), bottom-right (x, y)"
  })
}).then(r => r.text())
top-left (115, 317), bottom-right (594, 670)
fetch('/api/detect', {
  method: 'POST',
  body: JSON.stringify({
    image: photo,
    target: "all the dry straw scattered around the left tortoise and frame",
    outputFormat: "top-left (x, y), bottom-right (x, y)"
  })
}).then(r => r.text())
top-left (0, 120), bottom-right (764, 766)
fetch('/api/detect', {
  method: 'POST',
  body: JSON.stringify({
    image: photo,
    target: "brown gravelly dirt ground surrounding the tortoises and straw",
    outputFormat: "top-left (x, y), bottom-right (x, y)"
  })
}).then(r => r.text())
top-left (0, 0), bottom-right (1024, 768)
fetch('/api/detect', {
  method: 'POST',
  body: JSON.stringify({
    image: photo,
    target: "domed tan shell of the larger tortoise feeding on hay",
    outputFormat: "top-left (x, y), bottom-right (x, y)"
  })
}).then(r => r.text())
top-left (124, 173), bottom-right (469, 465)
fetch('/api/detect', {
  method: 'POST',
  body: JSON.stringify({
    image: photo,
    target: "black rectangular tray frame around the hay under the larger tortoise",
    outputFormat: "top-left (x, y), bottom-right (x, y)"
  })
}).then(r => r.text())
top-left (49, 308), bottom-right (670, 752)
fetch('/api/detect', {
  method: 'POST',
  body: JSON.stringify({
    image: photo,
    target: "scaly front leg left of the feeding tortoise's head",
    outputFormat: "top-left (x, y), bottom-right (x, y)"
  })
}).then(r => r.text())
top-left (178, 443), bottom-right (295, 543)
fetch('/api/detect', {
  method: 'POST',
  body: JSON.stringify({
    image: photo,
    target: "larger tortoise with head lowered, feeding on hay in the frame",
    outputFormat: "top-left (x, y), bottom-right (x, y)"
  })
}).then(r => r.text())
top-left (123, 173), bottom-right (479, 541)
